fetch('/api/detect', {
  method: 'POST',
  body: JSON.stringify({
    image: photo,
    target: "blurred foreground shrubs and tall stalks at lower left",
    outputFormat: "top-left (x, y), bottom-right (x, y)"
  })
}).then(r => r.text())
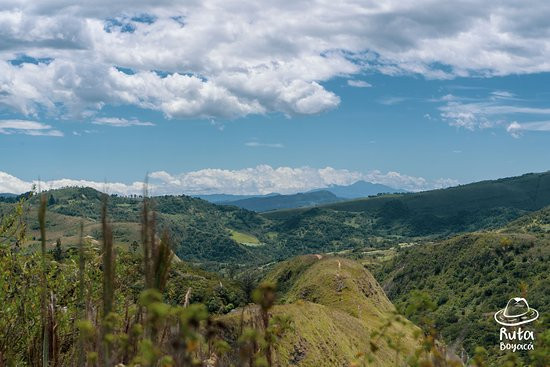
top-left (0, 194), bottom-right (266, 366)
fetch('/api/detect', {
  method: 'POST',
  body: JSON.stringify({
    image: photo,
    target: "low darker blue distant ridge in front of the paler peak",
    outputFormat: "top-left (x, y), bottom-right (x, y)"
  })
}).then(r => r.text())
top-left (220, 190), bottom-right (343, 212)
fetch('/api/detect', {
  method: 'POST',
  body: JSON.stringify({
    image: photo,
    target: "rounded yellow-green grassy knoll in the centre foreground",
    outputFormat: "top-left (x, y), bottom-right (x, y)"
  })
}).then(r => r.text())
top-left (224, 255), bottom-right (417, 367)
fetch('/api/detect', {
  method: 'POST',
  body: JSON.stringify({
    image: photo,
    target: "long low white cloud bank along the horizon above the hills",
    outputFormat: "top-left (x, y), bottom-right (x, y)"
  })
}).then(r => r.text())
top-left (0, 165), bottom-right (458, 195)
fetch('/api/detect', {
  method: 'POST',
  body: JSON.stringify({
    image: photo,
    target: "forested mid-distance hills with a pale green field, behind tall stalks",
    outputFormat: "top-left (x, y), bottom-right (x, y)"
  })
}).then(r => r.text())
top-left (4, 188), bottom-right (382, 268)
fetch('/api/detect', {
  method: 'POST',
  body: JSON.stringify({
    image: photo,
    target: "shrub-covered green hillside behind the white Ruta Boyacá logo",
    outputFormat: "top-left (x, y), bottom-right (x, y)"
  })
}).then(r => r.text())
top-left (376, 229), bottom-right (550, 365)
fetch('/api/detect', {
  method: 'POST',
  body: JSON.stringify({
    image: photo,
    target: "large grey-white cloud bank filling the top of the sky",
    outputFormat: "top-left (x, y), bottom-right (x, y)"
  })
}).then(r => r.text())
top-left (0, 0), bottom-right (550, 118)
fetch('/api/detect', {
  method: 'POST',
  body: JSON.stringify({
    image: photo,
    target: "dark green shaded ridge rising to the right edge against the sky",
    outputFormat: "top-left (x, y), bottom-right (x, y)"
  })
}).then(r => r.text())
top-left (264, 172), bottom-right (550, 236)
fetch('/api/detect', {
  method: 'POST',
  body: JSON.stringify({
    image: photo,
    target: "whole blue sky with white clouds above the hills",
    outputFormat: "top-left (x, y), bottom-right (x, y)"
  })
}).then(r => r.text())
top-left (0, 0), bottom-right (550, 194)
